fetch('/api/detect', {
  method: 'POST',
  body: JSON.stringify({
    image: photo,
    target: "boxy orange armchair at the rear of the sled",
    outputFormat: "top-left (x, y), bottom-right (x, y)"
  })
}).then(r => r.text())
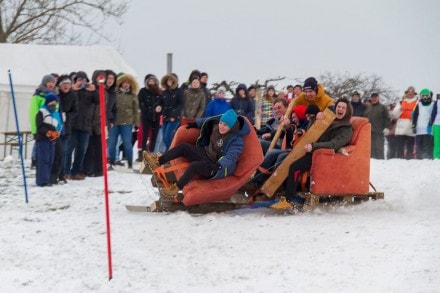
top-left (310, 117), bottom-right (371, 195)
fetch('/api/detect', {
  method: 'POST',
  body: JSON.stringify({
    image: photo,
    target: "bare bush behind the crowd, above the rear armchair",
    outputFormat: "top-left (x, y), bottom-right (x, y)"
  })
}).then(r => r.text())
top-left (318, 72), bottom-right (398, 103)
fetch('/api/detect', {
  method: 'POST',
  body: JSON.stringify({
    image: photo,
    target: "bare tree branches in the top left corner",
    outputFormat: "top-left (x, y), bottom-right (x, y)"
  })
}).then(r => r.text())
top-left (0, 0), bottom-right (128, 44)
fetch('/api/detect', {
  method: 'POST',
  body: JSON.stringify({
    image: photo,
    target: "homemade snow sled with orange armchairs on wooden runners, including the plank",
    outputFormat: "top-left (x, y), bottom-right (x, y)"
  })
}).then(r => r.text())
top-left (138, 110), bottom-right (384, 213)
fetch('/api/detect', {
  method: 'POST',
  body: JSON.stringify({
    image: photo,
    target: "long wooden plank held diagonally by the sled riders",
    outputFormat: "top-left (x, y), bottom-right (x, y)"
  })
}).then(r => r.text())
top-left (261, 109), bottom-right (335, 197)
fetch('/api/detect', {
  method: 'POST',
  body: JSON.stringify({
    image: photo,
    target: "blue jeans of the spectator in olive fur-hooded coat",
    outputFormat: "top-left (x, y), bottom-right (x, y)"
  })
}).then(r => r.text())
top-left (108, 124), bottom-right (133, 163)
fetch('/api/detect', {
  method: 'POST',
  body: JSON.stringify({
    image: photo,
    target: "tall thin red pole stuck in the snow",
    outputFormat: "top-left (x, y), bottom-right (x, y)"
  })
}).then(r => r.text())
top-left (98, 75), bottom-right (113, 281)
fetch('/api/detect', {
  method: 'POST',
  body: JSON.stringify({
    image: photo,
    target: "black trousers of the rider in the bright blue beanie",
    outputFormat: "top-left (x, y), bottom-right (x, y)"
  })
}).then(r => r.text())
top-left (159, 142), bottom-right (218, 189)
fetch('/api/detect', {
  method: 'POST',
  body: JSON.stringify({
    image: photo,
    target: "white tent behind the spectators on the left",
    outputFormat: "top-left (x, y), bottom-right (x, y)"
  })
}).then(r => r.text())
top-left (0, 44), bottom-right (136, 158)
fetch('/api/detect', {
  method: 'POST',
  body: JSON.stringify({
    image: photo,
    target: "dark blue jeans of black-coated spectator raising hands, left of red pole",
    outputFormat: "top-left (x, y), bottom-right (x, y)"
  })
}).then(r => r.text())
top-left (64, 129), bottom-right (90, 176)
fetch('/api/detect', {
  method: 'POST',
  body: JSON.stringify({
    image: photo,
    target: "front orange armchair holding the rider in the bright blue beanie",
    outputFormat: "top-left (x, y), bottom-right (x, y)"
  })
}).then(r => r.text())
top-left (170, 118), bottom-right (263, 206)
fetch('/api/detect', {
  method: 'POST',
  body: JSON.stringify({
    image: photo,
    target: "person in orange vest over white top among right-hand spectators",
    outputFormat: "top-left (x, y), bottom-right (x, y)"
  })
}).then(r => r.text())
top-left (390, 86), bottom-right (418, 160)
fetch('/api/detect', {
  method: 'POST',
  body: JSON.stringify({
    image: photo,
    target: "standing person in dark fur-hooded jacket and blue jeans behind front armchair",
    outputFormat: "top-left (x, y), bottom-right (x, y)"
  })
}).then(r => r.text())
top-left (159, 74), bottom-right (185, 149)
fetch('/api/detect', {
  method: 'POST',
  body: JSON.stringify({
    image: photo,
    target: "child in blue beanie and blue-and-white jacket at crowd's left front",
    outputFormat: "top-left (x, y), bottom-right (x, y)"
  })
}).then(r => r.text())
top-left (35, 93), bottom-right (63, 186)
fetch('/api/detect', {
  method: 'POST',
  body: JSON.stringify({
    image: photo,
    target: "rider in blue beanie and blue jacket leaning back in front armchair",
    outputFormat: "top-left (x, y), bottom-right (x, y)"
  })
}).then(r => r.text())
top-left (146, 109), bottom-right (250, 196)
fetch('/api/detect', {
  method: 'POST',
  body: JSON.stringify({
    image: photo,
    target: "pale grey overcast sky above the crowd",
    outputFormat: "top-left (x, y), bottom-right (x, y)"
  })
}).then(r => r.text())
top-left (102, 0), bottom-right (440, 94)
